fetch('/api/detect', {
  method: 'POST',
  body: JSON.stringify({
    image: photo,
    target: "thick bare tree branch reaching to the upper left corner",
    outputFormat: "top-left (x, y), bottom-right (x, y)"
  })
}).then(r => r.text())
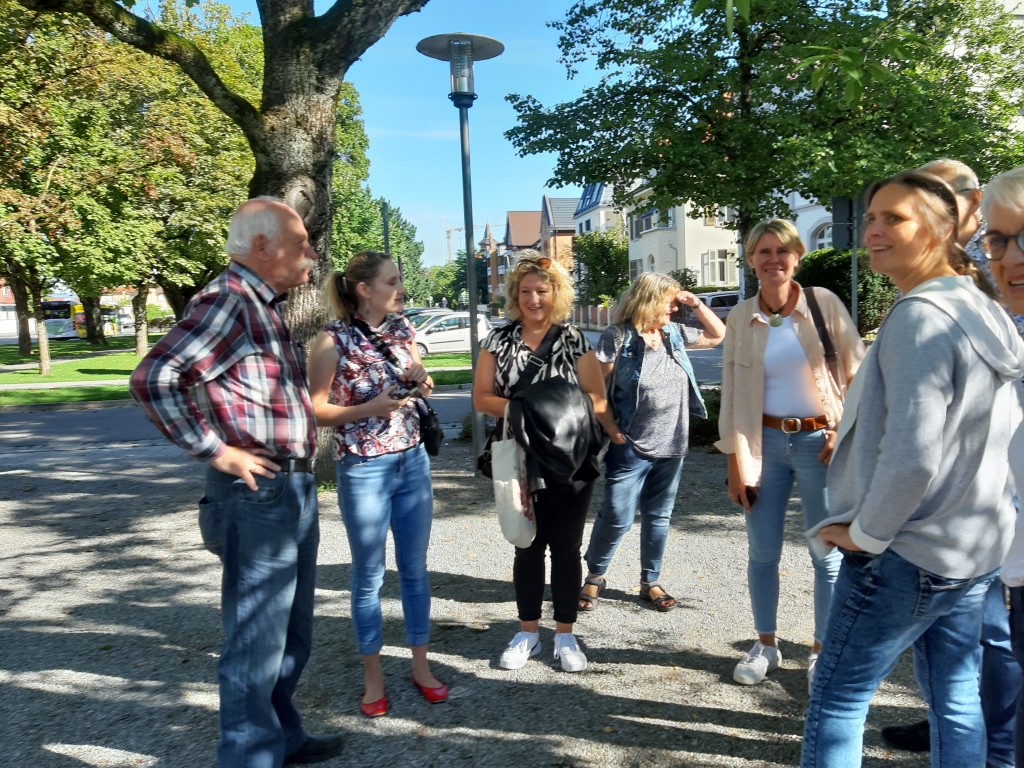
top-left (18, 0), bottom-right (263, 142)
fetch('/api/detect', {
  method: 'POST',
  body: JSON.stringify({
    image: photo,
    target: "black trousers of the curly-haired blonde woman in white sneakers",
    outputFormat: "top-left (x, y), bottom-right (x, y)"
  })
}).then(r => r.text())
top-left (512, 482), bottom-right (594, 624)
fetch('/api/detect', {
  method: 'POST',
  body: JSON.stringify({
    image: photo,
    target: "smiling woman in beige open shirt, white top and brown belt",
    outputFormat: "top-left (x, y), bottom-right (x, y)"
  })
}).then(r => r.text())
top-left (716, 219), bottom-right (864, 685)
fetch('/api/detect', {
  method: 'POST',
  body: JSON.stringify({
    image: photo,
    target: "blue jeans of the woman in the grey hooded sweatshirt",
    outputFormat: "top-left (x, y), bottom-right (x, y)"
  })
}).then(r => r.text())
top-left (801, 550), bottom-right (997, 768)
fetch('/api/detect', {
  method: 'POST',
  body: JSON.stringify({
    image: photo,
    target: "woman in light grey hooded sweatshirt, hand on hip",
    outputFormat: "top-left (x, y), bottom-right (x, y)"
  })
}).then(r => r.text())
top-left (802, 171), bottom-right (1024, 768)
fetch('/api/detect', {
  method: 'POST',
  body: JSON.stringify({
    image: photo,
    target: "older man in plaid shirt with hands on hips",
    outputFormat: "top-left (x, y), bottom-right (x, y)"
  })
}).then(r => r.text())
top-left (131, 198), bottom-right (342, 768)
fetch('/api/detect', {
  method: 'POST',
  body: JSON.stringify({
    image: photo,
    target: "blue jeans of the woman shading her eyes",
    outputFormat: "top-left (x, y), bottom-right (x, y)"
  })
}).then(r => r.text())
top-left (586, 442), bottom-right (683, 584)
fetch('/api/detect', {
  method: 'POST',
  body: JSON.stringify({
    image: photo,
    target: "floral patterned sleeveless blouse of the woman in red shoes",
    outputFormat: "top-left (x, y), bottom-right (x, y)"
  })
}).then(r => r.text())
top-left (324, 314), bottom-right (420, 461)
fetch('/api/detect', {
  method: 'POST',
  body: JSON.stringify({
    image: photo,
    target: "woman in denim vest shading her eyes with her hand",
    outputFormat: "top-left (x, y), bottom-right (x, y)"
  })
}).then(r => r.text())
top-left (580, 272), bottom-right (725, 611)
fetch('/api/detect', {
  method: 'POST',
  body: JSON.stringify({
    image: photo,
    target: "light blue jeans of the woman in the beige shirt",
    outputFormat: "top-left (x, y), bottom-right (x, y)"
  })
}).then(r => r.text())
top-left (745, 427), bottom-right (842, 641)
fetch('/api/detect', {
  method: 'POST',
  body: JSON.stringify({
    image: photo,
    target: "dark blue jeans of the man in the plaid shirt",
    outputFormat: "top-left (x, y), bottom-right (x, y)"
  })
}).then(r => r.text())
top-left (200, 467), bottom-right (319, 768)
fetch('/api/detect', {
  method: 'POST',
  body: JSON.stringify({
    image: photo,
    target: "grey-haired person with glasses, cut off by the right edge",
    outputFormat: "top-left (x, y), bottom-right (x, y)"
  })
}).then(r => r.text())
top-left (981, 166), bottom-right (1024, 755)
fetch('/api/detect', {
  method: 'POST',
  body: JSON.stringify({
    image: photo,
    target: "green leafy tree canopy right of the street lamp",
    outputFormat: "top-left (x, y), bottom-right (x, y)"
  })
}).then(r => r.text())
top-left (506, 0), bottom-right (1024, 250)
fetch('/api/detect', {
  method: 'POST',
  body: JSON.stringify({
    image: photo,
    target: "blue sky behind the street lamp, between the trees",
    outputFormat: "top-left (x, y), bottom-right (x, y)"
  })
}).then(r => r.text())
top-left (232, 0), bottom-right (596, 265)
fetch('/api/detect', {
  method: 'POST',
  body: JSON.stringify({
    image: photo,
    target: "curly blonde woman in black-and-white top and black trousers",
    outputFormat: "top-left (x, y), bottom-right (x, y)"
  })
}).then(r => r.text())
top-left (473, 251), bottom-right (617, 672)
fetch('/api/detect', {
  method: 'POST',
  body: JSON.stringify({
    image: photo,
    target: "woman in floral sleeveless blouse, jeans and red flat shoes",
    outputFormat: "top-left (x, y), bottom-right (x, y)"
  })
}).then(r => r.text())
top-left (309, 252), bottom-right (447, 717)
